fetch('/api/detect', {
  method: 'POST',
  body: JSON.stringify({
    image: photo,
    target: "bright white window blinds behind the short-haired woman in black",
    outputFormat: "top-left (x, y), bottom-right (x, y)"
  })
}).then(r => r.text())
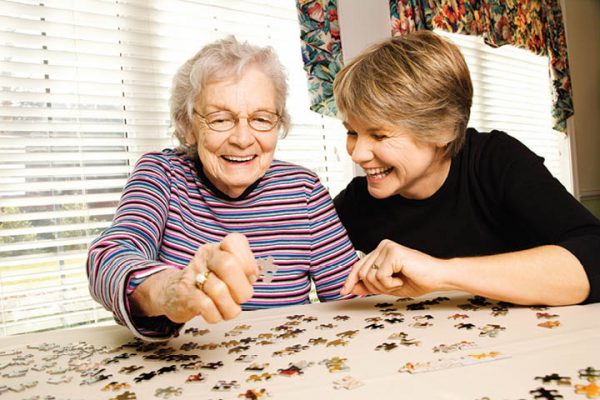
top-left (436, 30), bottom-right (572, 192)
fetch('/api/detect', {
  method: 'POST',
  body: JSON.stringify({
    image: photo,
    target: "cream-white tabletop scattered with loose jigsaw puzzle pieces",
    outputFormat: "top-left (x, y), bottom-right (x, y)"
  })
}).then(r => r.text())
top-left (0, 293), bottom-right (600, 400)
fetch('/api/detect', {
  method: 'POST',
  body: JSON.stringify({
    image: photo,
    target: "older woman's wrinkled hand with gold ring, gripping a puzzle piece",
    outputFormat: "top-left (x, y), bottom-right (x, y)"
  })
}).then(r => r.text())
top-left (157, 233), bottom-right (259, 323)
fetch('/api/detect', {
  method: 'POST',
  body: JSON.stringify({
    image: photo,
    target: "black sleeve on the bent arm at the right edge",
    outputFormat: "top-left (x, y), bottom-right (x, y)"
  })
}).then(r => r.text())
top-left (491, 134), bottom-right (600, 303)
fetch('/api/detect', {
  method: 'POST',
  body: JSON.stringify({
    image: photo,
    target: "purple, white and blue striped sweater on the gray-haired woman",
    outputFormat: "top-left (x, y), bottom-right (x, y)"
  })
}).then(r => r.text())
top-left (87, 150), bottom-right (357, 339)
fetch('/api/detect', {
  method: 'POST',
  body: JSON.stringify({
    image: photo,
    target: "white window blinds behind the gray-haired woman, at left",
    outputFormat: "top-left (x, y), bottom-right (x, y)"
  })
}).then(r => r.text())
top-left (0, 0), bottom-right (350, 335)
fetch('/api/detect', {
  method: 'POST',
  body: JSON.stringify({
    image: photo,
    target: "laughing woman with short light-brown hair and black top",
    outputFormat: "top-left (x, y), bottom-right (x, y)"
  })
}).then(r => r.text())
top-left (334, 31), bottom-right (600, 305)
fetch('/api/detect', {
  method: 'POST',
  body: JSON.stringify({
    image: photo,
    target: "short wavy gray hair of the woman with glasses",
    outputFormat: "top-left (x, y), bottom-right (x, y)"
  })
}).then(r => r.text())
top-left (169, 36), bottom-right (290, 158)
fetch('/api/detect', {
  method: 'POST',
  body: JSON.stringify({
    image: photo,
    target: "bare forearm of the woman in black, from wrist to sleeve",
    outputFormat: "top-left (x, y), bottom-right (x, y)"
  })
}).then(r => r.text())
top-left (442, 246), bottom-right (590, 305)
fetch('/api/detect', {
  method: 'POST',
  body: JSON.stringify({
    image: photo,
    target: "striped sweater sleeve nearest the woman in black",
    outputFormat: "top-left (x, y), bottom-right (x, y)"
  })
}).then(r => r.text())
top-left (308, 178), bottom-right (358, 301)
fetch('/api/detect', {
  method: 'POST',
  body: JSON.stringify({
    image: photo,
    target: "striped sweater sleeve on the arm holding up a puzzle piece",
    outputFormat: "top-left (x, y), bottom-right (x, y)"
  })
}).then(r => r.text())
top-left (87, 153), bottom-right (182, 340)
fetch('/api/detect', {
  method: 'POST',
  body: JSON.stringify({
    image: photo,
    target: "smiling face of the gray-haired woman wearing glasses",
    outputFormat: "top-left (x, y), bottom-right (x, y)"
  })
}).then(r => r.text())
top-left (187, 67), bottom-right (277, 198)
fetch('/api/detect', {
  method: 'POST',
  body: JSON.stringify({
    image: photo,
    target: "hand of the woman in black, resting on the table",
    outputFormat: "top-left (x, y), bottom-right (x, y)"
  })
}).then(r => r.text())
top-left (341, 240), bottom-right (445, 297)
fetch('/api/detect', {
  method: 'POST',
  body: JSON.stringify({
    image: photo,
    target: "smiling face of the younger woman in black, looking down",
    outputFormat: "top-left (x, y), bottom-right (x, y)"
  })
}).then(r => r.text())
top-left (344, 115), bottom-right (450, 199)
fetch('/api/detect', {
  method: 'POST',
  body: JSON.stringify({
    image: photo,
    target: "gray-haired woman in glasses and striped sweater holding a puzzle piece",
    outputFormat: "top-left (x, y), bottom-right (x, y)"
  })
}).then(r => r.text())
top-left (87, 37), bottom-right (357, 339)
